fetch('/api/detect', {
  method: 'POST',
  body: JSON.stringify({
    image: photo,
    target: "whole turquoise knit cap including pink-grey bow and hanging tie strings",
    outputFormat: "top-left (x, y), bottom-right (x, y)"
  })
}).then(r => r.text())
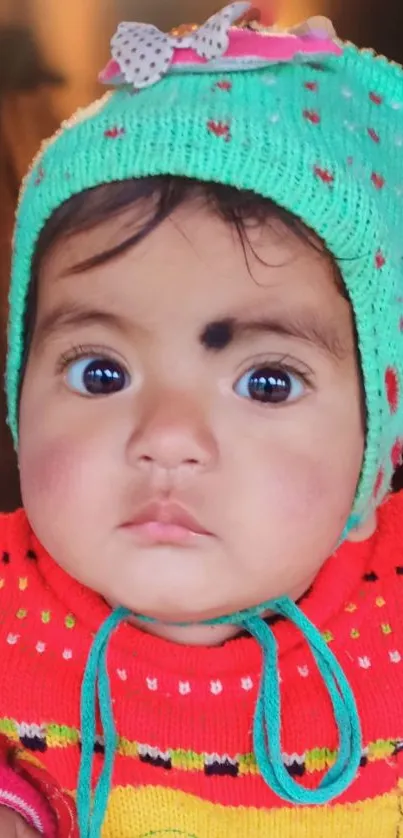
top-left (6, 2), bottom-right (403, 838)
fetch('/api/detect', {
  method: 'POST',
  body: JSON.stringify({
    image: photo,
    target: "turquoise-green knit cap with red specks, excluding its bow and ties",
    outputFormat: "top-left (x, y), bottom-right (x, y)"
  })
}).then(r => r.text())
top-left (6, 6), bottom-right (403, 525)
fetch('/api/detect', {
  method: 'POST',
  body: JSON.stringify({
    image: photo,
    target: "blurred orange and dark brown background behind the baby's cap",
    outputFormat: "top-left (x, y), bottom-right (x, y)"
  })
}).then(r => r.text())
top-left (0, 0), bottom-right (403, 510)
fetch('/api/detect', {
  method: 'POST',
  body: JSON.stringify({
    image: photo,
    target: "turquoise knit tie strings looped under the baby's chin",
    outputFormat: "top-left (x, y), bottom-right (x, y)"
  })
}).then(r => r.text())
top-left (77, 597), bottom-right (362, 838)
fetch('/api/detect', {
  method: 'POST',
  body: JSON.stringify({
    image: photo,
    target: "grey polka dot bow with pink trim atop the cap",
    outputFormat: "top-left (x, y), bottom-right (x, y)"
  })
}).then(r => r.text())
top-left (99, 2), bottom-right (342, 90)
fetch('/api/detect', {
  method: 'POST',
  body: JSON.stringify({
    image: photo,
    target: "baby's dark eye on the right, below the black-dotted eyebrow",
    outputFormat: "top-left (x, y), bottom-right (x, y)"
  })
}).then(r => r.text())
top-left (234, 365), bottom-right (305, 404)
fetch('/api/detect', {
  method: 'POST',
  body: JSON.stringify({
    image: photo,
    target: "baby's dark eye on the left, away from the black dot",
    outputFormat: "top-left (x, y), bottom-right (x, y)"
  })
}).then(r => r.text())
top-left (66, 357), bottom-right (130, 396)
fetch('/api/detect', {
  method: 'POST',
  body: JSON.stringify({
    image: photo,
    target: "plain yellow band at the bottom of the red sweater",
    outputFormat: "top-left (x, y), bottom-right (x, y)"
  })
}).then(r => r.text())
top-left (102, 786), bottom-right (403, 838)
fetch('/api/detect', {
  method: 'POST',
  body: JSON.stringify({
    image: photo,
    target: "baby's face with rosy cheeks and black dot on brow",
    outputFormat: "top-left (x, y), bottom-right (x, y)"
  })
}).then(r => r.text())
top-left (20, 200), bottom-right (367, 642)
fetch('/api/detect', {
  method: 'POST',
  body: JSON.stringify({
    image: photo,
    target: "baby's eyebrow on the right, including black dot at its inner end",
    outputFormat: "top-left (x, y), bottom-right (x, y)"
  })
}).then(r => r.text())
top-left (200, 312), bottom-right (349, 360)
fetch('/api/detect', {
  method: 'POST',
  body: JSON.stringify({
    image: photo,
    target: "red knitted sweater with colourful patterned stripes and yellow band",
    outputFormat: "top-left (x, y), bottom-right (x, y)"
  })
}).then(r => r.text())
top-left (0, 493), bottom-right (403, 838)
